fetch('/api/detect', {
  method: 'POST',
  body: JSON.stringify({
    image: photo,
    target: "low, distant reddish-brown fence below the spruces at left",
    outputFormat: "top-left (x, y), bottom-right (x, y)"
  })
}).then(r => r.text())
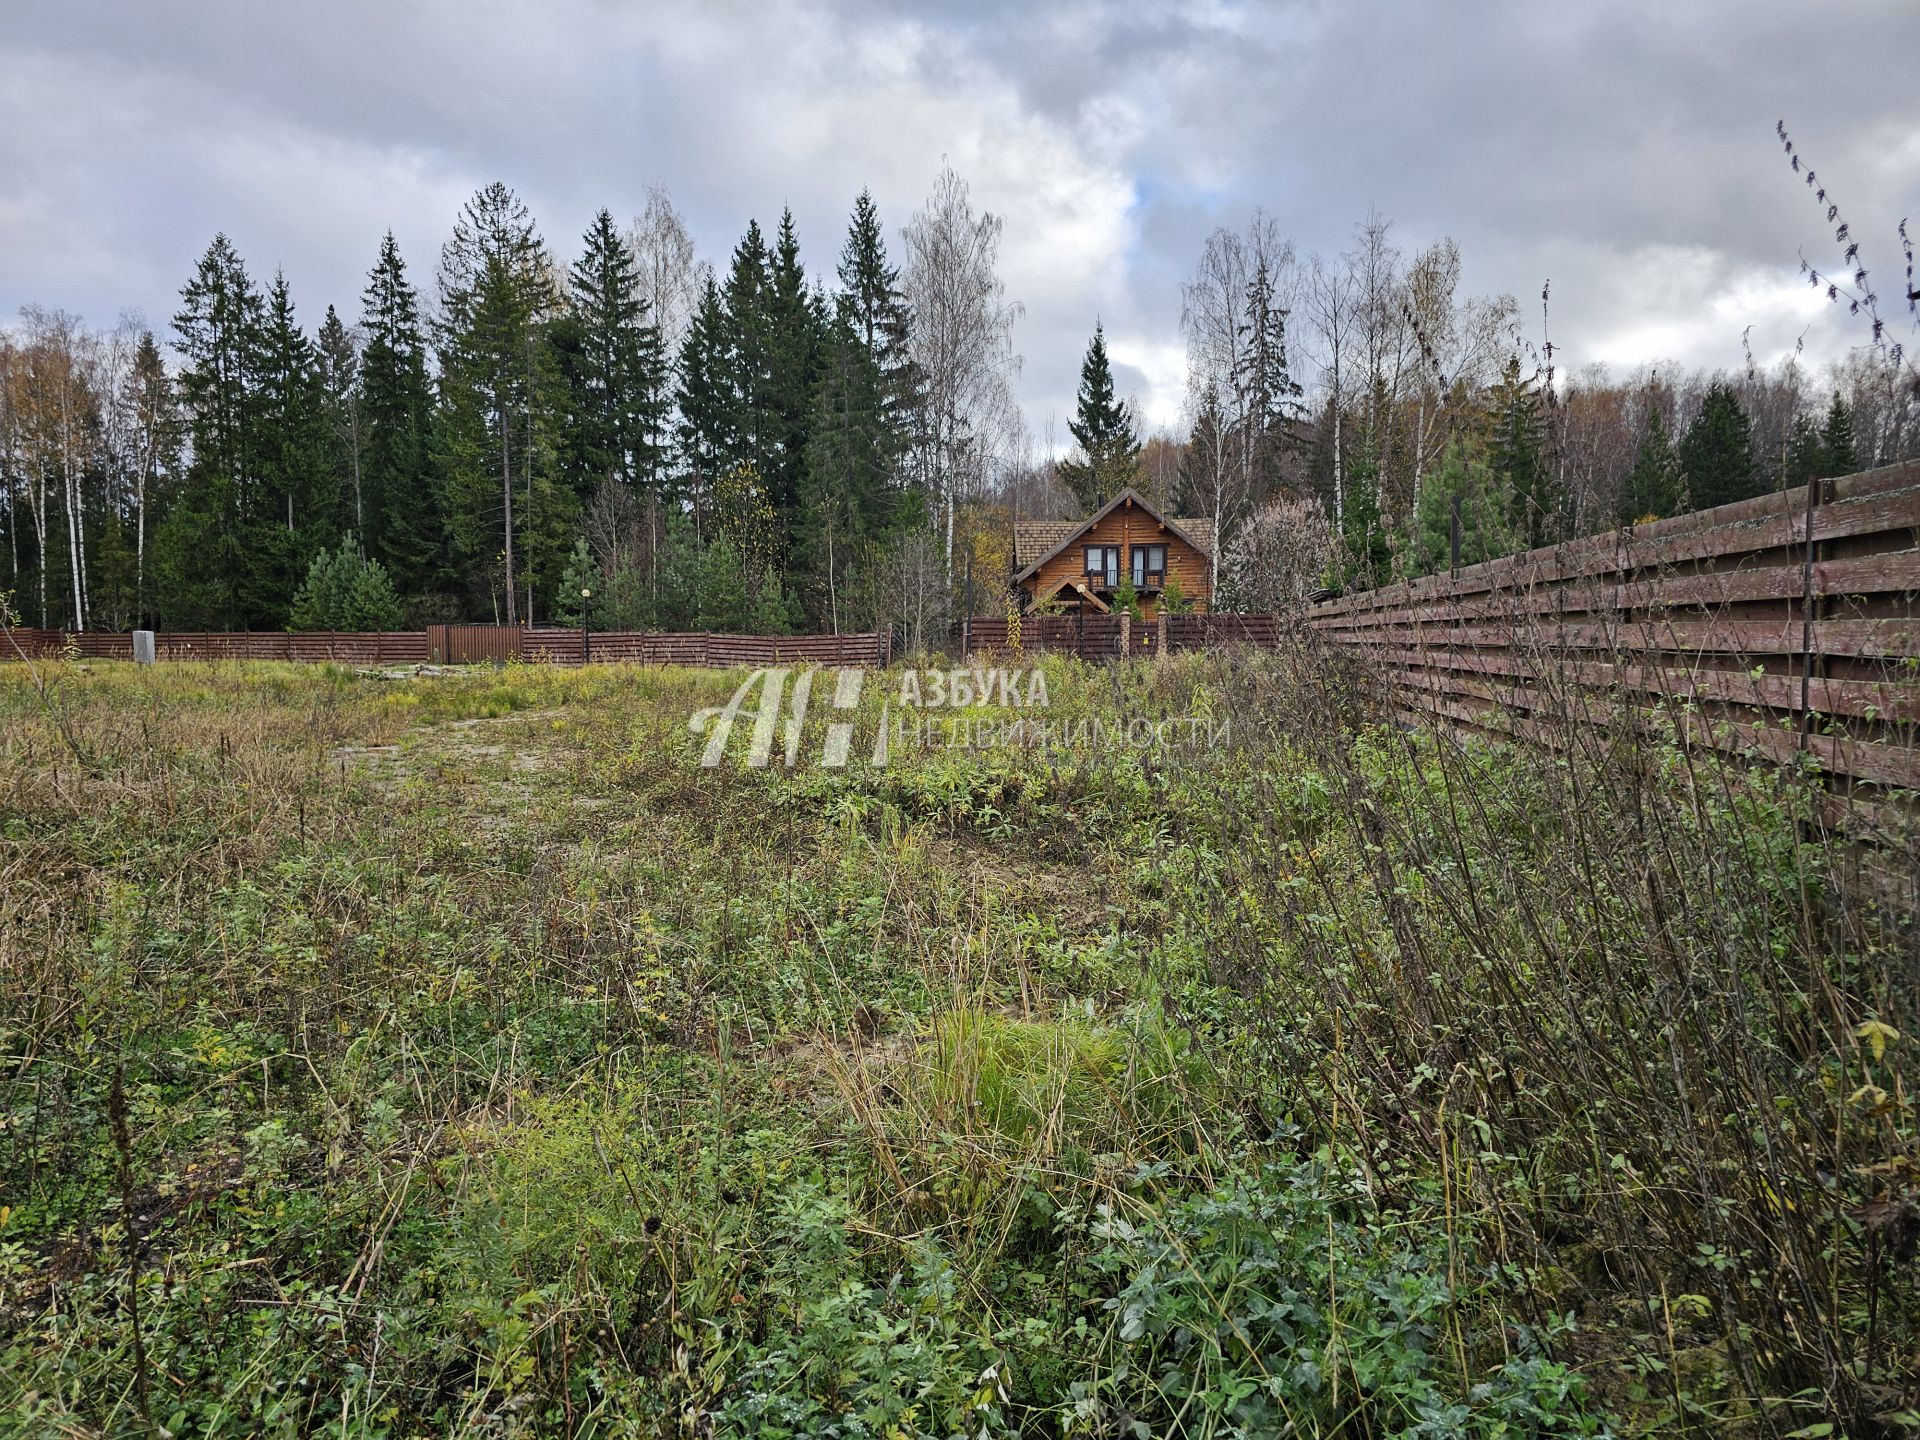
top-left (0, 626), bottom-right (893, 668)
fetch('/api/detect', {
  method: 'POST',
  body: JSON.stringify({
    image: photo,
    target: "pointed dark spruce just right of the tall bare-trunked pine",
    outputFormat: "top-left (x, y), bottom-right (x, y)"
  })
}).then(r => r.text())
top-left (568, 209), bottom-right (666, 495)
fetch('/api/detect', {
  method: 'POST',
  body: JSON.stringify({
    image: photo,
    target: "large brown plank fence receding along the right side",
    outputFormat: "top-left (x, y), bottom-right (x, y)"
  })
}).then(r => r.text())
top-left (1308, 465), bottom-right (1920, 802)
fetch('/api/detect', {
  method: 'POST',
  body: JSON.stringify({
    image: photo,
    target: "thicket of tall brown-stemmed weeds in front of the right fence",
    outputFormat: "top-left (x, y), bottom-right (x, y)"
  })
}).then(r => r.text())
top-left (1187, 641), bottom-right (1920, 1434)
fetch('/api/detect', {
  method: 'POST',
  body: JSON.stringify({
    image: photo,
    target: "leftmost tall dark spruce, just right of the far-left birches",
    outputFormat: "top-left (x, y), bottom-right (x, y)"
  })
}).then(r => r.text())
top-left (154, 234), bottom-right (267, 630)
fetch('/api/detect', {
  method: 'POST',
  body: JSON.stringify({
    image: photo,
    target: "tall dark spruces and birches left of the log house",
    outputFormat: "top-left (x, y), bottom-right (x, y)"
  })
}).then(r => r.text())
top-left (0, 171), bottom-right (1018, 632)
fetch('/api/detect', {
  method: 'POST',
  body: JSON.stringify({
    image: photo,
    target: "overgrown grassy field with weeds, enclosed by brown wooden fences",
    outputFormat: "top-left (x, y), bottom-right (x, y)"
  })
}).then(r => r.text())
top-left (0, 649), bottom-right (1920, 1436)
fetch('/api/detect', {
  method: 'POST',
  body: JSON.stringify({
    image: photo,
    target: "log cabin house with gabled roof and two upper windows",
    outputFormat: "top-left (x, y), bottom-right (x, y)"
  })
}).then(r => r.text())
top-left (1014, 490), bottom-right (1213, 620)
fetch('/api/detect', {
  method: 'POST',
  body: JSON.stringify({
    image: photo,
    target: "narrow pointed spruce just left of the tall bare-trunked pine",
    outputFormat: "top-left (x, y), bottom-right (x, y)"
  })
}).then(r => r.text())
top-left (359, 230), bottom-right (444, 595)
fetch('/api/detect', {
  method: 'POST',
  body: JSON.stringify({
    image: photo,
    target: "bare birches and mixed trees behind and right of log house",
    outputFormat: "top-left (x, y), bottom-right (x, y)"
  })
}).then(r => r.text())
top-left (1025, 211), bottom-right (1920, 611)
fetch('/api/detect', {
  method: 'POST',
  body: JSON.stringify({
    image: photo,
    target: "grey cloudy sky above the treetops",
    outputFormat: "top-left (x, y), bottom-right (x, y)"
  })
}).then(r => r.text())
top-left (0, 0), bottom-right (1920, 444)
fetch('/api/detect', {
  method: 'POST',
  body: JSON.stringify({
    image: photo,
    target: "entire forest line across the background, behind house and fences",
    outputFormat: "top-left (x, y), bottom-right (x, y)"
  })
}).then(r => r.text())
top-left (0, 169), bottom-right (1920, 639)
